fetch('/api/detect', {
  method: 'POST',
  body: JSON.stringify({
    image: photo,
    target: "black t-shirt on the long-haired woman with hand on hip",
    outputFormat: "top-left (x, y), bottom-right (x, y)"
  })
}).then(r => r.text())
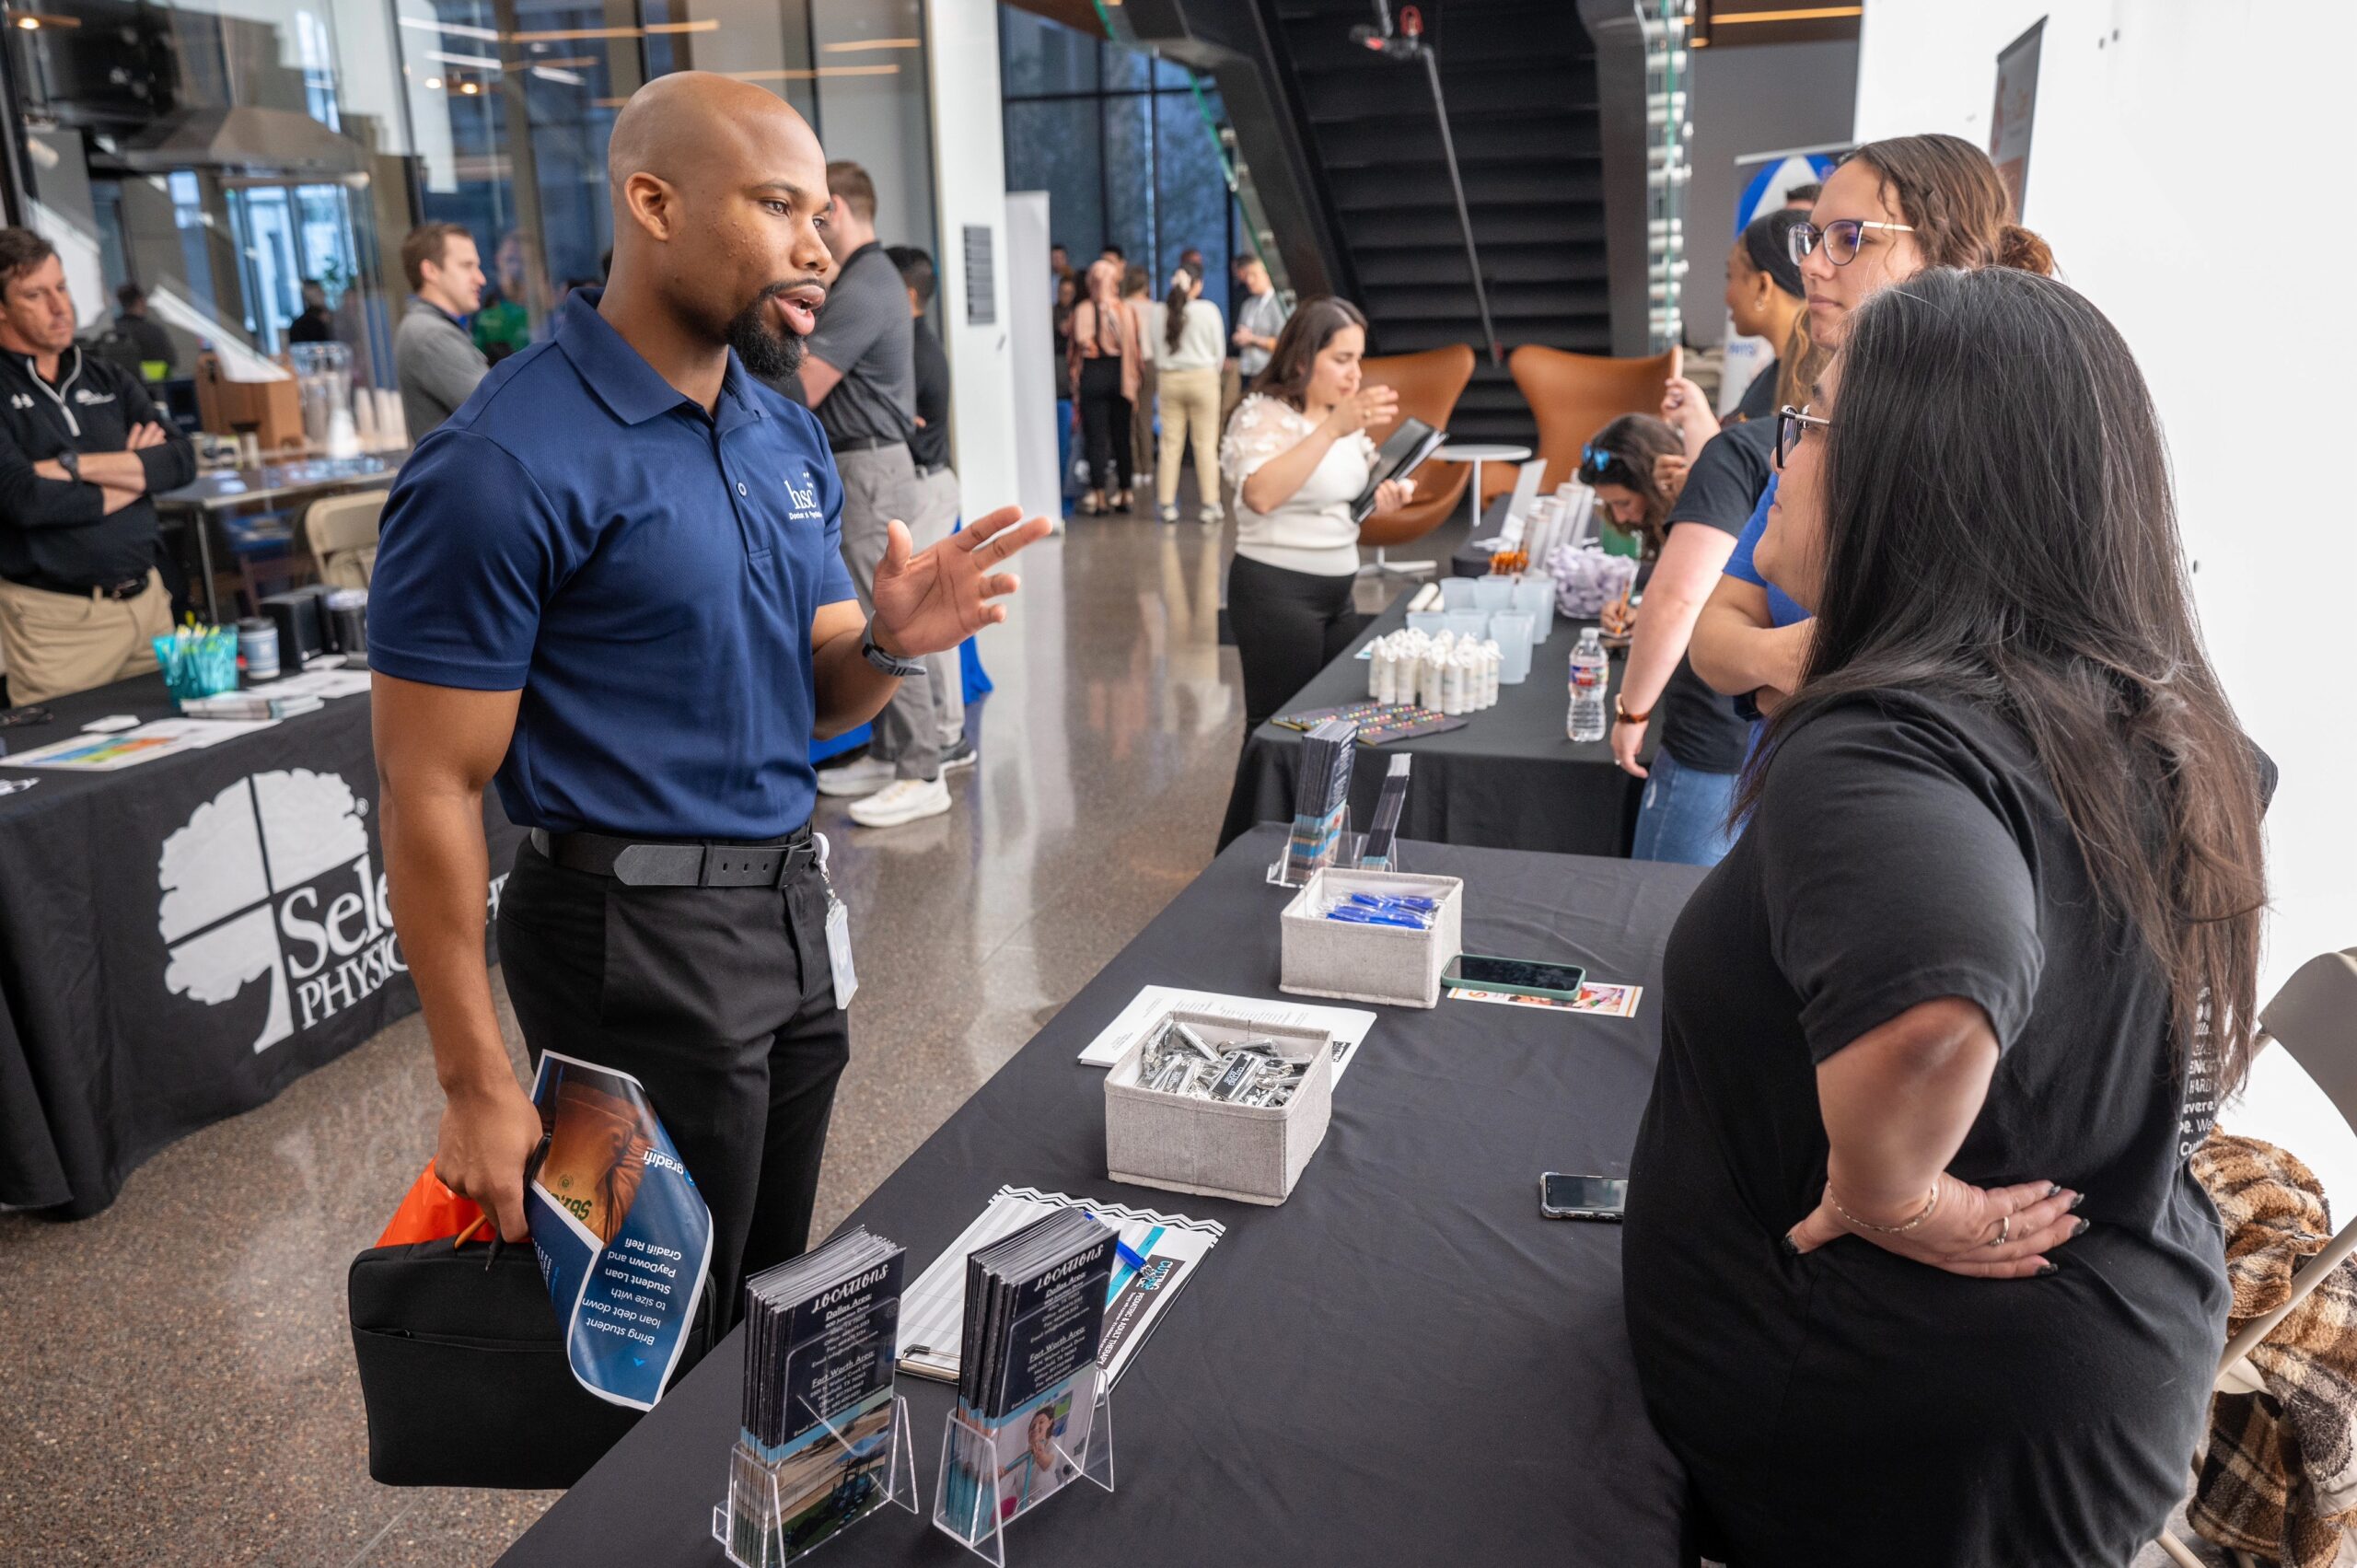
top-left (1621, 691), bottom-right (2227, 1563)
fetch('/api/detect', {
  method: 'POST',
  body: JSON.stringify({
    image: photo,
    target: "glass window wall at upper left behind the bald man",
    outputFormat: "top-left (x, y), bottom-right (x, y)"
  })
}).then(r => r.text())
top-left (0, 0), bottom-right (938, 405)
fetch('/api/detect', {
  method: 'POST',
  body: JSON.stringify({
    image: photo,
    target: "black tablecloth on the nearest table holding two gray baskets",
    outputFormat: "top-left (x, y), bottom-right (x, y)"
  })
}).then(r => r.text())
top-left (500, 830), bottom-right (1701, 1568)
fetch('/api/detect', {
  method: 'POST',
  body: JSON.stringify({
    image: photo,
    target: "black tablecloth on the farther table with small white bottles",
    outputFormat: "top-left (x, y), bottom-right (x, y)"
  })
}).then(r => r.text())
top-left (1219, 594), bottom-right (1643, 870)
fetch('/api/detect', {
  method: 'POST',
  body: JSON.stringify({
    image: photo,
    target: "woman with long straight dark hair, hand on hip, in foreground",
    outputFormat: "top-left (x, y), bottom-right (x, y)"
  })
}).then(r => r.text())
top-left (1621, 262), bottom-right (2272, 1568)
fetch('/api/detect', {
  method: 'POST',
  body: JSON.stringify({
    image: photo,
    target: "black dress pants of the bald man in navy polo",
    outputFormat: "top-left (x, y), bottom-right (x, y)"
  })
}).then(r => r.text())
top-left (500, 840), bottom-right (851, 1337)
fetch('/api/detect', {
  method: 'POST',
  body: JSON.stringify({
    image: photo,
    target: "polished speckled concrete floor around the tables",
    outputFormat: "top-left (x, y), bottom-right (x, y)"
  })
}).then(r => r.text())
top-left (0, 507), bottom-right (2224, 1568)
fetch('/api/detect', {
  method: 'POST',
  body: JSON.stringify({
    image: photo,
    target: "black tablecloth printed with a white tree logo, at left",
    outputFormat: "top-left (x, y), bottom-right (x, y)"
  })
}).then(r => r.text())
top-left (0, 677), bottom-right (521, 1219)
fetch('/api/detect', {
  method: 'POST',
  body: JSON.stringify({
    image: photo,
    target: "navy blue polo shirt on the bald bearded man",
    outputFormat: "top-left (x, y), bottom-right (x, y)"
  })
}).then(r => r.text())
top-left (367, 290), bottom-right (853, 840)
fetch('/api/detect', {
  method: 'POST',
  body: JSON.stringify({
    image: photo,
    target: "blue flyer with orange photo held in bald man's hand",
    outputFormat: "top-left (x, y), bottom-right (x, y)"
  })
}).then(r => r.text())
top-left (523, 1051), bottom-right (712, 1410)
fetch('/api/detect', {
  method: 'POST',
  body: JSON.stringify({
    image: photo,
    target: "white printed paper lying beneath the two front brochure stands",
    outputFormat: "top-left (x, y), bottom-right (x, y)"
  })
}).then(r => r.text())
top-left (900, 1186), bottom-right (1228, 1382)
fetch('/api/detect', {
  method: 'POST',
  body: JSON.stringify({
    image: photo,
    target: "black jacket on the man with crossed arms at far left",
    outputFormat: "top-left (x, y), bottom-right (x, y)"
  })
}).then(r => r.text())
top-left (0, 344), bottom-right (195, 592)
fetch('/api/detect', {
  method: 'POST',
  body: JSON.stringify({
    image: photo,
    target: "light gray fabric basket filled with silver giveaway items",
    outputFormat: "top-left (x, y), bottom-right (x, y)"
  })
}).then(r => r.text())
top-left (1106, 1007), bottom-right (1334, 1202)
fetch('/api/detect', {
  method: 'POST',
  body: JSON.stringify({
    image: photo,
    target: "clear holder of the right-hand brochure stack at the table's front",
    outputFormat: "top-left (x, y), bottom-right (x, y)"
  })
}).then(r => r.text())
top-left (934, 1361), bottom-right (1112, 1568)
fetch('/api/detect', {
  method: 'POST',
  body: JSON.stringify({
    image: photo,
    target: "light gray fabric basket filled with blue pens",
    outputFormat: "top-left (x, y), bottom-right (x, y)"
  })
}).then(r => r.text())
top-left (1278, 865), bottom-right (1466, 1007)
